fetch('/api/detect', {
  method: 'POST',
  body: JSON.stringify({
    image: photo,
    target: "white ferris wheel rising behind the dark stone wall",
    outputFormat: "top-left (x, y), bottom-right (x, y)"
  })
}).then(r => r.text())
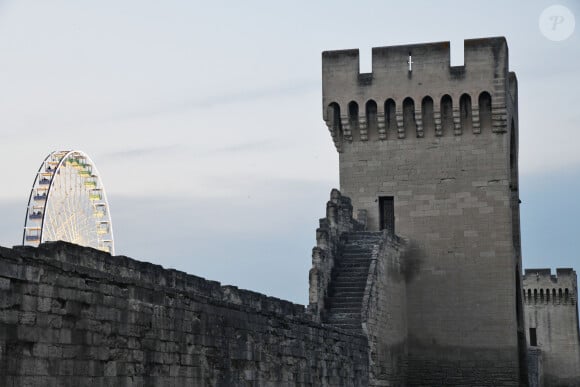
top-left (22, 151), bottom-right (115, 254)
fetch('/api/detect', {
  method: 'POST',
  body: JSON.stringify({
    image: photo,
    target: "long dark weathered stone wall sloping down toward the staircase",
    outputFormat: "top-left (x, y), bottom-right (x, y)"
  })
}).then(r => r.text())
top-left (0, 242), bottom-right (368, 387)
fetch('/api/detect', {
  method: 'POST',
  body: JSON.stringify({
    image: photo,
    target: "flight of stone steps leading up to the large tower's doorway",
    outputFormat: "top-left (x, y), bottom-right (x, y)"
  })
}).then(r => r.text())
top-left (323, 231), bottom-right (383, 332)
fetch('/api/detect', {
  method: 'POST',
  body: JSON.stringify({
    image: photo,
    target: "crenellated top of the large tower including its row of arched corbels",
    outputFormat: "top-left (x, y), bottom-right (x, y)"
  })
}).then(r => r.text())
top-left (322, 37), bottom-right (517, 152)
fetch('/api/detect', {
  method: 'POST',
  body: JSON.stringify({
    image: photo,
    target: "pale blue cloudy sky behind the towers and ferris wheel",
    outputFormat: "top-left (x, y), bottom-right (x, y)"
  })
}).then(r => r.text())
top-left (0, 0), bottom-right (580, 303)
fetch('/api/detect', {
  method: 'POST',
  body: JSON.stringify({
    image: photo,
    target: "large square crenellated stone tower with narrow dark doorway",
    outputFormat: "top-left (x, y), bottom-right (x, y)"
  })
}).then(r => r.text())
top-left (322, 38), bottom-right (527, 386)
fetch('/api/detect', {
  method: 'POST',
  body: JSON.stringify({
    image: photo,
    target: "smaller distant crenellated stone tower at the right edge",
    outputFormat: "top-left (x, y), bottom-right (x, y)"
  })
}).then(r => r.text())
top-left (524, 269), bottom-right (580, 387)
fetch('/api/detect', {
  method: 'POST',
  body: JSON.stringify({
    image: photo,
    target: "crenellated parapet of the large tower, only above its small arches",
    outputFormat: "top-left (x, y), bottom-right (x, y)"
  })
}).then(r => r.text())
top-left (322, 37), bottom-right (515, 120)
